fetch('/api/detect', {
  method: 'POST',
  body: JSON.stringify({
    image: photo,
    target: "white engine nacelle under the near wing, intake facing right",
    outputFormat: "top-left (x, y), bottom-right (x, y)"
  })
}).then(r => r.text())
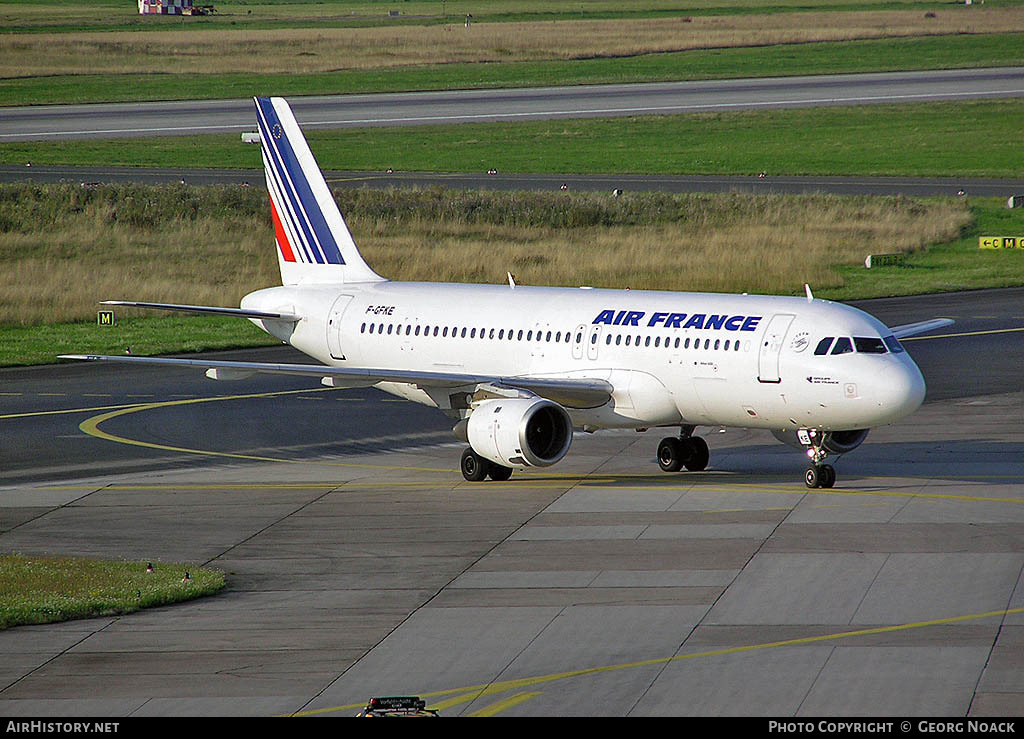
top-left (466, 398), bottom-right (572, 467)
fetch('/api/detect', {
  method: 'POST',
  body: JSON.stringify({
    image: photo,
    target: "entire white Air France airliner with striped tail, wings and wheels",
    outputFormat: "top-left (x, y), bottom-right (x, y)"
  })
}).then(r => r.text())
top-left (66, 97), bottom-right (952, 488)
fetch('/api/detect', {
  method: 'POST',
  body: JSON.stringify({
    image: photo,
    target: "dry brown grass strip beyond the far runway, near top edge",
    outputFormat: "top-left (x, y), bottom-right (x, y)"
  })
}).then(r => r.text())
top-left (0, 6), bottom-right (1024, 78)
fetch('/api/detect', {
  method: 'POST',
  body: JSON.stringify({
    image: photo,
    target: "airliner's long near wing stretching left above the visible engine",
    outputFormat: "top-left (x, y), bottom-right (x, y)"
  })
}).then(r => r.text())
top-left (60, 354), bottom-right (613, 408)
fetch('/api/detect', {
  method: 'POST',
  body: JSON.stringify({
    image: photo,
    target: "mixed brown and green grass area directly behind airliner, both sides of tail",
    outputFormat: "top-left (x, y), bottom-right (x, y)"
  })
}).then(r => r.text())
top-left (6, 185), bottom-right (1024, 364)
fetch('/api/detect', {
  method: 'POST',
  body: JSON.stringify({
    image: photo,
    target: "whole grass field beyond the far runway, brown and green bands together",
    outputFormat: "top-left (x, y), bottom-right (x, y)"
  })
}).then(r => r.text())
top-left (0, 0), bottom-right (1024, 104)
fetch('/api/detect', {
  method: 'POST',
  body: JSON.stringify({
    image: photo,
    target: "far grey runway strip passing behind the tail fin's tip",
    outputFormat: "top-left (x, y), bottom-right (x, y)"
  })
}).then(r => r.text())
top-left (0, 68), bottom-right (1024, 143)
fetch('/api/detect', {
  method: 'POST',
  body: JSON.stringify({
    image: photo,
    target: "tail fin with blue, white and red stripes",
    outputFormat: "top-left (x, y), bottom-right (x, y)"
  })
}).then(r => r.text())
top-left (254, 97), bottom-right (383, 285)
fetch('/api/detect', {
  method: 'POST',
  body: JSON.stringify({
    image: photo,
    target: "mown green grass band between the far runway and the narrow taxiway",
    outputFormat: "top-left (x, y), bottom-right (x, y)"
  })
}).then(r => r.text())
top-left (0, 98), bottom-right (1024, 177)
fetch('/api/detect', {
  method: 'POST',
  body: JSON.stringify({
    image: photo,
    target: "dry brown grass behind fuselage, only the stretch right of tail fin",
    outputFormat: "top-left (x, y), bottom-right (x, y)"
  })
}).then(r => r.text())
top-left (353, 195), bottom-right (970, 294)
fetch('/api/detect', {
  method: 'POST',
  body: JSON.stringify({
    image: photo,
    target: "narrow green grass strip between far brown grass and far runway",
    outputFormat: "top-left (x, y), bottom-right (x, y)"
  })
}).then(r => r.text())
top-left (0, 34), bottom-right (1024, 105)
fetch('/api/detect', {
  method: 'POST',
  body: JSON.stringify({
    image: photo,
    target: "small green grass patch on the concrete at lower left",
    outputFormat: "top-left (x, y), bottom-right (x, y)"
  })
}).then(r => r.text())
top-left (0, 554), bottom-right (224, 629)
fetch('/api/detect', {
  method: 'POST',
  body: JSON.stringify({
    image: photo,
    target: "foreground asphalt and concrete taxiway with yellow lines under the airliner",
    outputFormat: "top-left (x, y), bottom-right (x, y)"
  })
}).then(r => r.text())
top-left (0, 289), bottom-right (1024, 716)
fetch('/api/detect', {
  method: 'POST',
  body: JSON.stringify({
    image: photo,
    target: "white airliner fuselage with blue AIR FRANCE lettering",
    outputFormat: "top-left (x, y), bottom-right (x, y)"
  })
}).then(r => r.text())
top-left (242, 281), bottom-right (925, 431)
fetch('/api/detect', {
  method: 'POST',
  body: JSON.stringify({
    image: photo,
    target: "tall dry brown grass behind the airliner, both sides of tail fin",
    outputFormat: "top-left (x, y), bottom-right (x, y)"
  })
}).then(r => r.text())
top-left (0, 185), bottom-right (970, 324)
